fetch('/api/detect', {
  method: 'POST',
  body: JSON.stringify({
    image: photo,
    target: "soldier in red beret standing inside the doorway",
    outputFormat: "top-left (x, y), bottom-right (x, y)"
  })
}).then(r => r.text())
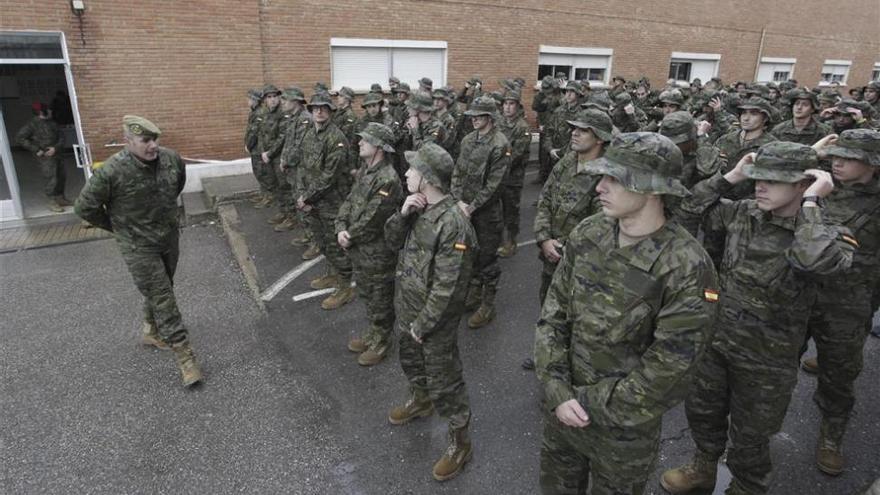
top-left (15, 103), bottom-right (71, 213)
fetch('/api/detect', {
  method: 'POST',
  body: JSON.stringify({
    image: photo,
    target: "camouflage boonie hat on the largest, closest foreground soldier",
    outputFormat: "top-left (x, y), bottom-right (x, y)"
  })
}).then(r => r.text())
top-left (585, 132), bottom-right (691, 197)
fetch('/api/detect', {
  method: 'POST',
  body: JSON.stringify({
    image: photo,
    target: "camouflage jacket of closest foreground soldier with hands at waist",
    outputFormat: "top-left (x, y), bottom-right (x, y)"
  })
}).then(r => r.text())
top-left (535, 215), bottom-right (718, 428)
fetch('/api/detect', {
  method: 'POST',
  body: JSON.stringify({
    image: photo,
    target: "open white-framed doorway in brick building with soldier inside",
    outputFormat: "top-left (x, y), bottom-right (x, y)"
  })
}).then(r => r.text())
top-left (0, 31), bottom-right (87, 221)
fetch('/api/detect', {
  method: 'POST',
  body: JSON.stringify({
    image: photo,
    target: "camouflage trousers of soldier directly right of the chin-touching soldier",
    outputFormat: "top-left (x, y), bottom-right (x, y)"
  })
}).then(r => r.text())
top-left (470, 199), bottom-right (504, 295)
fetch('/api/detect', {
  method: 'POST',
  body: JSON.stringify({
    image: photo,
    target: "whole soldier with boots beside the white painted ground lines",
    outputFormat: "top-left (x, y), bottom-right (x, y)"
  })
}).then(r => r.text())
top-left (295, 93), bottom-right (354, 310)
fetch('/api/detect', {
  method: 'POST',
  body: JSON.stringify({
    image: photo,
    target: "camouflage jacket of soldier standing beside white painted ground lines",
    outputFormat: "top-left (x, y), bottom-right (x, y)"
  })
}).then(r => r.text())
top-left (296, 122), bottom-right (351, 209)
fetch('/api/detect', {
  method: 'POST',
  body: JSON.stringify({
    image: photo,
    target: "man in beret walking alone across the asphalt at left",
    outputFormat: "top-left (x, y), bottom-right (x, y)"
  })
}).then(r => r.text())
top-left (74, 115), bottom-right (202, 387)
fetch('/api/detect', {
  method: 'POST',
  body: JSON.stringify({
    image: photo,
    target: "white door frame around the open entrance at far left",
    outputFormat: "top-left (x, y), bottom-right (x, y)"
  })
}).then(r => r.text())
top-left (0, 30), bottom-right (92, 221)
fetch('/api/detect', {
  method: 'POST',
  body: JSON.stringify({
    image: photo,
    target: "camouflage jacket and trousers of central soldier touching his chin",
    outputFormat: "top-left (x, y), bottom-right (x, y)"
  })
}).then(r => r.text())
top-left (385, 196), bottom-right (477, 431)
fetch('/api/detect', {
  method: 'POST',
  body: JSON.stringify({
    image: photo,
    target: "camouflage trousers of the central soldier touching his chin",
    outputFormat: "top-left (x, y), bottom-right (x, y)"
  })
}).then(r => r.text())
top-left (398, 315), bottom-right (471, 432)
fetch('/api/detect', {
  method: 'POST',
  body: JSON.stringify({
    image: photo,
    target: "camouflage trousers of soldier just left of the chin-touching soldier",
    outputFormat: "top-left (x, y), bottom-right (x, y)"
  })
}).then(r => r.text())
top-left (348, 246), bottom-right (397, 350)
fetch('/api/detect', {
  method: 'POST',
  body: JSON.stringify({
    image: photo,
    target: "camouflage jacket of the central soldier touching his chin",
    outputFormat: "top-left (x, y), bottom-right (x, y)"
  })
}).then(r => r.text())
top-left (385, 196), bottom-right (477, 336)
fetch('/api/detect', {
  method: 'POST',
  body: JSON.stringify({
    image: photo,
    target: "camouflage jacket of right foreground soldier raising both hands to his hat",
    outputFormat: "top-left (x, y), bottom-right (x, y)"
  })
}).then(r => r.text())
top-left (679, 174), bottom-right (853, 369)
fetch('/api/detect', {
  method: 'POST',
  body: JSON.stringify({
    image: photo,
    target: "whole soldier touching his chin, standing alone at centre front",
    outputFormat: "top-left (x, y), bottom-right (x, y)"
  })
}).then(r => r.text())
top-left (385, 143), bottom-right (477, 481)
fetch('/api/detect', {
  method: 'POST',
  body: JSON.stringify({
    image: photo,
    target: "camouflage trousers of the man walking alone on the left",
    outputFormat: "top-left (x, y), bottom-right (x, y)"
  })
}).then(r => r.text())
top-left (121, 240), bottom-right (187, 344)
